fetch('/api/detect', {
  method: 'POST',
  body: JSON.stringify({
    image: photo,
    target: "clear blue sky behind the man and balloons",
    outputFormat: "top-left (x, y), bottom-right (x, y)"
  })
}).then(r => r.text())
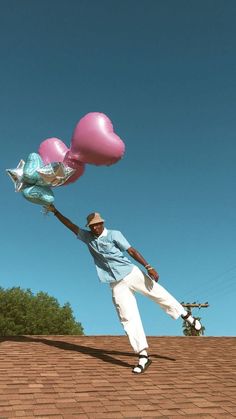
top-left (0, 0), bottom-right (236, 336)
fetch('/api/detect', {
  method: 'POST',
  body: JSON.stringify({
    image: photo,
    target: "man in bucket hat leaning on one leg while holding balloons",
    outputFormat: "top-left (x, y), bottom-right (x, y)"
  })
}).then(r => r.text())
top-left (48, 205), bottom-right (201, 374)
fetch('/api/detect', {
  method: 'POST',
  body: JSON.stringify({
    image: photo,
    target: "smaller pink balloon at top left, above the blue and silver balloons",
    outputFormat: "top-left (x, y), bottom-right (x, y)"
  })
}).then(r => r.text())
top-left (38, 138), bottom-right (69, 164)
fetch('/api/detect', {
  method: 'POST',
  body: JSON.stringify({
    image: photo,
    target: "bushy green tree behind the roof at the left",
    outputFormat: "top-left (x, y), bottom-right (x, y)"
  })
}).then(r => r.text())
top-left (0, 287), bottom-right (84, 336)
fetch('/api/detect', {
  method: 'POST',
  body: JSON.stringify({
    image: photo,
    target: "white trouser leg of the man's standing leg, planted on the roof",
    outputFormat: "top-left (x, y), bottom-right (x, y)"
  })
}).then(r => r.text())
top-left (110, 273), bottom-right (148, 353)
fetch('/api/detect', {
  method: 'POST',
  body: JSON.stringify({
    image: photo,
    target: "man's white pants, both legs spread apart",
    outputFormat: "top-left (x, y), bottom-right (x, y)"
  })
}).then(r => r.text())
top-left (110, 266), bottom-right (185, 353)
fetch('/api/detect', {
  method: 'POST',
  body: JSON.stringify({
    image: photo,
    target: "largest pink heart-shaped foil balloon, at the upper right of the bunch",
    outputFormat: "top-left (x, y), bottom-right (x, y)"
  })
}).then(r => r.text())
top-left (70, 112), bottom-right (125, 165)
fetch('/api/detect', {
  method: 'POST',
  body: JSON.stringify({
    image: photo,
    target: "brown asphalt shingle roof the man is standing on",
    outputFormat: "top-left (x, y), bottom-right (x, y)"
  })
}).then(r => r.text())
top-left (0, 336), bottom-right (236, 419)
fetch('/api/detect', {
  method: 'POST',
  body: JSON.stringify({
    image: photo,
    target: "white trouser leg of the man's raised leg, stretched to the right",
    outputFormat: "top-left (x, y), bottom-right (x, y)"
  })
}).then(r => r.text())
top-left (127, 266), bottom-right (185, 319)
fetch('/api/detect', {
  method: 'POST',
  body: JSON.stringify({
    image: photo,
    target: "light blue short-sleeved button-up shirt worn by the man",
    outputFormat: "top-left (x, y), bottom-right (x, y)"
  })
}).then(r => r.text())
top-left (77, 228), bottom-right (134, 283)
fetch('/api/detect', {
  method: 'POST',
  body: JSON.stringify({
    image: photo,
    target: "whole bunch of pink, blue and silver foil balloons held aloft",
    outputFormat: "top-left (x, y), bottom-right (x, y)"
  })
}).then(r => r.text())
top-left (7, 112), bottom-right (125, 206)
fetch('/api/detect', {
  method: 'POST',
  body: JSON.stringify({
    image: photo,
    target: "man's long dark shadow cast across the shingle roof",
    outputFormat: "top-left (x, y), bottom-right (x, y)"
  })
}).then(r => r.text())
top-left (0, 336), bottom-right (175, 368)
